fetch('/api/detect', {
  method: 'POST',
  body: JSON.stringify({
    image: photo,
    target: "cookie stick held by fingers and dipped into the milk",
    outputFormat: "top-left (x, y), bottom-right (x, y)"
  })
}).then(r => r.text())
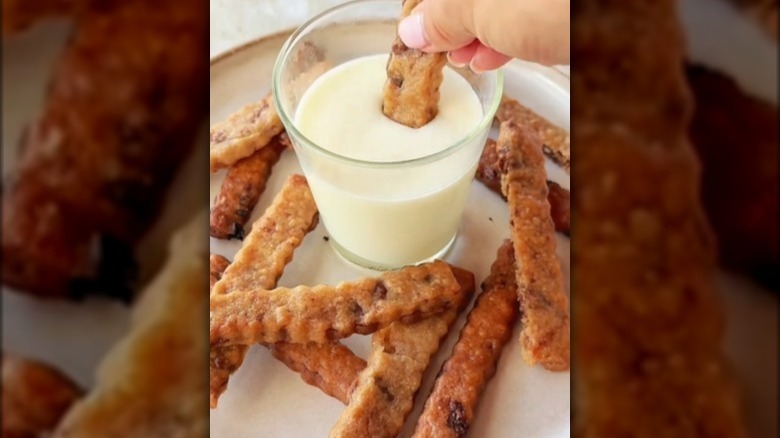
top-left (382, 0), bottom-right (447, 128)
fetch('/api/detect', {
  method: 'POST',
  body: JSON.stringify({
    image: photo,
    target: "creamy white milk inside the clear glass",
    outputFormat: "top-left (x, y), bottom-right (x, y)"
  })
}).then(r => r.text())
top-left (295, 55), bottom-right (487, 267)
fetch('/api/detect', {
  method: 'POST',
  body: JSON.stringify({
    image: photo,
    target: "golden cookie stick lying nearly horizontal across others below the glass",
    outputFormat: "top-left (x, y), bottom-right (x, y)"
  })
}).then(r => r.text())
top-left (210, 261), bottom-right (461, 346)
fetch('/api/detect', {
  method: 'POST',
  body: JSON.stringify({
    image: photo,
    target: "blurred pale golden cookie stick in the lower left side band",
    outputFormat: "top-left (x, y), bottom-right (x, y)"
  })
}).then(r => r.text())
top-left (53, 212), bottom-right (209, 438)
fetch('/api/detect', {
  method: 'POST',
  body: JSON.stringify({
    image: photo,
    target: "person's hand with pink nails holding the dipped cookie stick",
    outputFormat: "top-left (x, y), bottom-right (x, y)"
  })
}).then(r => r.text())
top-left (398, 0), bottom-right (570, 72)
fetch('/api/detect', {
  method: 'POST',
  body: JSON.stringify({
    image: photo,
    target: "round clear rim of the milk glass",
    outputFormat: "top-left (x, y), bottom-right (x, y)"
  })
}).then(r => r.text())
top-left (271, 0), bottom-right (504, 168)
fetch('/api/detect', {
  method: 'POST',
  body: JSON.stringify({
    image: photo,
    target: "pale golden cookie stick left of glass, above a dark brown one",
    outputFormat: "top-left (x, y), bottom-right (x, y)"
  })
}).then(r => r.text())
top-left (209, 93), bottom-right (284, 172)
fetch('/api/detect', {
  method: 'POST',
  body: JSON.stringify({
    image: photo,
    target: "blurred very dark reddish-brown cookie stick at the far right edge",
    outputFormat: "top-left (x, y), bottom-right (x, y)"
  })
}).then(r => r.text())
top-left (687, 66), bottom-right (780, 288)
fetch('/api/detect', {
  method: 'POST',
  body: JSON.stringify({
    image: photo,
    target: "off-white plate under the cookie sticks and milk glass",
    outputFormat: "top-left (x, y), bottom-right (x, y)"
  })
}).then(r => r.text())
top-left (210, 34), bottom-right (570, 438)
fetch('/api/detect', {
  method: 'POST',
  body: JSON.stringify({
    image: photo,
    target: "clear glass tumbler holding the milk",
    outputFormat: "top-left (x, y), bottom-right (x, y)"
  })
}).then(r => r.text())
top-left (273, 0), bottom-right (503, 270)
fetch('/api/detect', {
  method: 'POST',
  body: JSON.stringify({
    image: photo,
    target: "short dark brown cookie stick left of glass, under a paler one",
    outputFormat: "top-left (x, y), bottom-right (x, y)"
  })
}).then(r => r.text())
top-left (209, 136), bottom-right (285, 240)
